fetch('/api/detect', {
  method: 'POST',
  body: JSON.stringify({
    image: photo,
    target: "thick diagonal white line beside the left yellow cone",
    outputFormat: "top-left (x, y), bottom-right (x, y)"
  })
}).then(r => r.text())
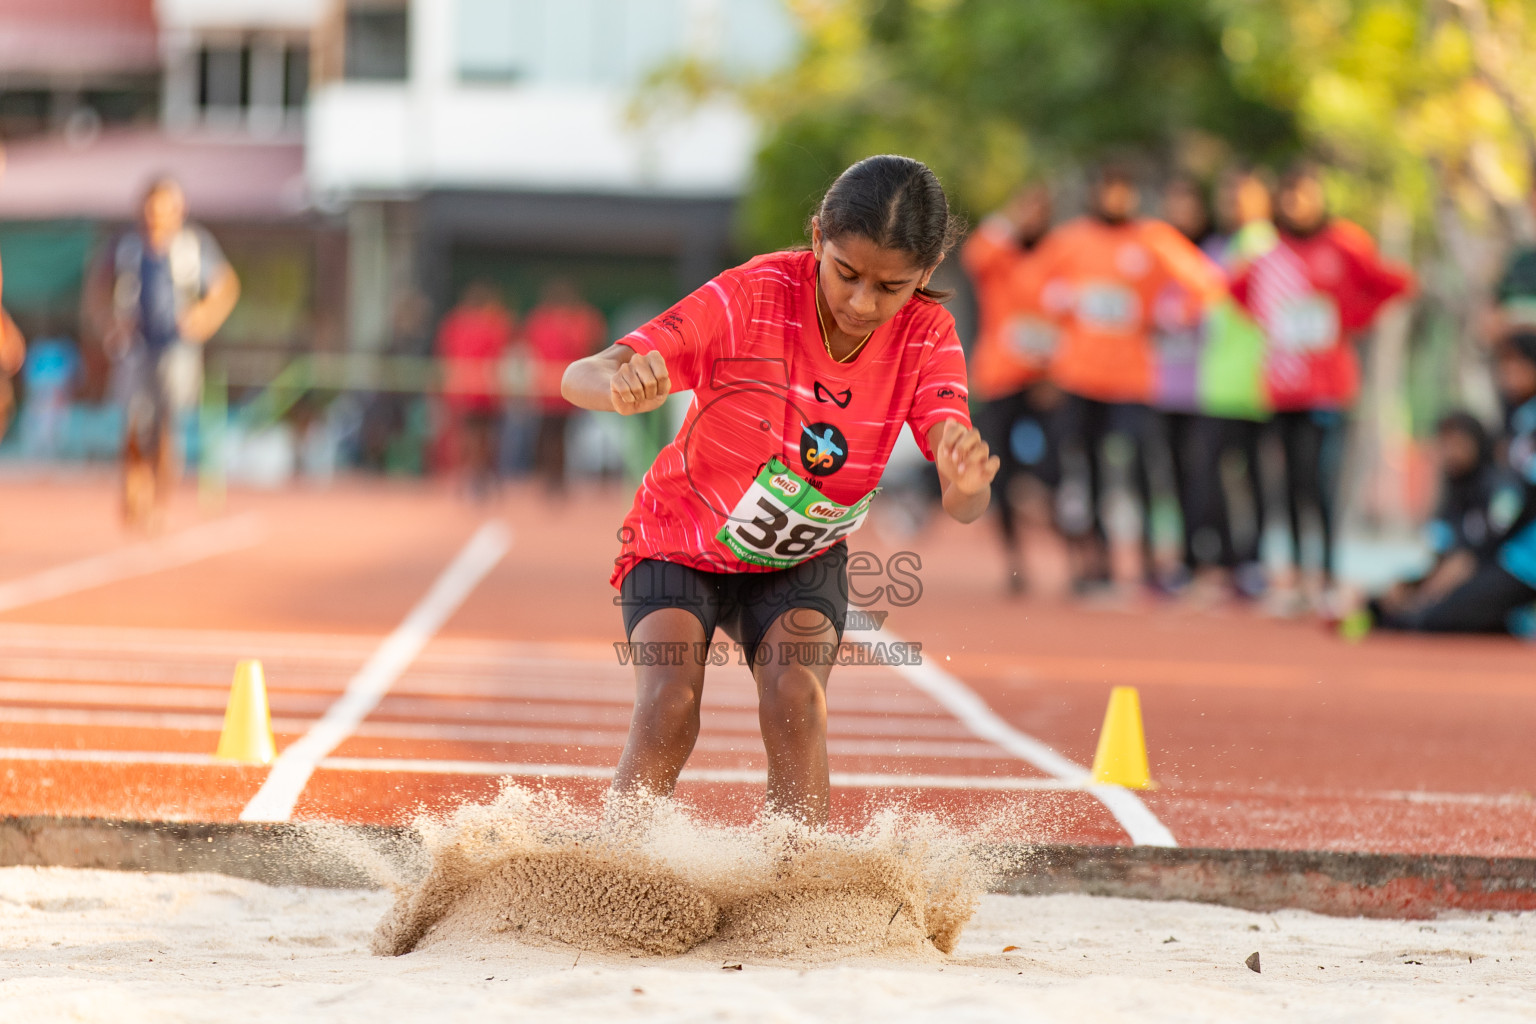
top-left (240, 520), bottom-right (511, 821)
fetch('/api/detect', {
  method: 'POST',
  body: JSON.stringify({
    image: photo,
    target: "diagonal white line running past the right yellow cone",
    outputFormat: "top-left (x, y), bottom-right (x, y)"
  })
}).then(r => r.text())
top-left (846, 629), bottom-right (1178, 846)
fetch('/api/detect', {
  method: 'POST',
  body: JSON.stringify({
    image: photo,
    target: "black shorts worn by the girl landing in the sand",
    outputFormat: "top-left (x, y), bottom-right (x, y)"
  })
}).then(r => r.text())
top-left (619, 540), bottom-right (848, 659)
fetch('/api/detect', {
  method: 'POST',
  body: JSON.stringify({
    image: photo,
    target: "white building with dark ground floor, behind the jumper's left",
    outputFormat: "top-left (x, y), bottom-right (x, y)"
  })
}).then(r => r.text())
top-left (307, 0), bottom-right (796, 348)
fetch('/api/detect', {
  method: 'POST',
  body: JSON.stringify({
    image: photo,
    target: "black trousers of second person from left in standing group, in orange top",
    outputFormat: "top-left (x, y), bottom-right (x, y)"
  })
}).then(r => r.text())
top-left (1057, 395), bottom-right (1163, 582)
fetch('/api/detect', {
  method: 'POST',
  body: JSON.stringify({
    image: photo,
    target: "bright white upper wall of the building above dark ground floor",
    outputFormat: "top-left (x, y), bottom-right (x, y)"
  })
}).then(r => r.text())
top-left (307, 0), bottom-right (794, 197)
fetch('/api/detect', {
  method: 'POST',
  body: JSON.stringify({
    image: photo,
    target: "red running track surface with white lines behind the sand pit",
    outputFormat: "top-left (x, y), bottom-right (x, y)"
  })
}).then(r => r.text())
top-left (0, 477), bottom-right (1536, 857)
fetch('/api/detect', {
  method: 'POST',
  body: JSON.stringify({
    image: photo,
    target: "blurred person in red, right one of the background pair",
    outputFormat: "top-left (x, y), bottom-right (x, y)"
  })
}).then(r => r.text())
top-left (522, 278), bottom-right (608, 494)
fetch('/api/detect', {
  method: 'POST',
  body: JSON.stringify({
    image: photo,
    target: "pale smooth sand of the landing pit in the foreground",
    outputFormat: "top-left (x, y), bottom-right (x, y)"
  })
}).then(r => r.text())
top-left (0, 867), bottom-right (1536, 1024)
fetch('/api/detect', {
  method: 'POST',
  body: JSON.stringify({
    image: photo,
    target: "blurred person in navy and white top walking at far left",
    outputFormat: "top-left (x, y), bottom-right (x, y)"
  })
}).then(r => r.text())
top-left (86, 177), bottom-right (240, 528)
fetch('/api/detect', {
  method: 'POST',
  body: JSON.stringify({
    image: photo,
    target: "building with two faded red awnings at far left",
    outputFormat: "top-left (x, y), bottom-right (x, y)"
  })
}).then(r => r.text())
top-left (0, 0), bottom-right (336, 390)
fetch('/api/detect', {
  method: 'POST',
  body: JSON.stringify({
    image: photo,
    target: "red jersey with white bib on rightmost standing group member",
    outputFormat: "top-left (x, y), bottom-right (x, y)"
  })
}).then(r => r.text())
top-left (1232, 220), bottom-right (1413, 410)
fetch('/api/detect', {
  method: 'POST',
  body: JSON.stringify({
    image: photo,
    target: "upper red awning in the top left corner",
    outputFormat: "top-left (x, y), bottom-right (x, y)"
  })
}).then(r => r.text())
top-left (0, 0), bottom-right (160, 78)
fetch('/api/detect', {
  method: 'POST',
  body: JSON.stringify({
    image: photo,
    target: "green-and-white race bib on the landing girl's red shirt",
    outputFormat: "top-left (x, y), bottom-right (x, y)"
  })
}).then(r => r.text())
top-left (714, 459), bottom-right (880, 570)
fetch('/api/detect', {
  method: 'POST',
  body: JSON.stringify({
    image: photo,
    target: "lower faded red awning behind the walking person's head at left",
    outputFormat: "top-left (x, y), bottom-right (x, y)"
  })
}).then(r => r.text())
top-left (0, 129), bottom-right (309, 221)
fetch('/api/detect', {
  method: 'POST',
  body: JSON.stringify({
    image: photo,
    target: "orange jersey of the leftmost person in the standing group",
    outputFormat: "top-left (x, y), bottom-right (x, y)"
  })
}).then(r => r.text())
top-left (960, 221), bottom-right (1060, 401)
